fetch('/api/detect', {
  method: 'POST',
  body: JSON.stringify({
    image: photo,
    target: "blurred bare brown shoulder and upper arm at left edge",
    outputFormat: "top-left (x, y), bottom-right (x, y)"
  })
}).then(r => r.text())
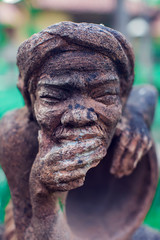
top-left (0, 108), bottom-right (38, 239)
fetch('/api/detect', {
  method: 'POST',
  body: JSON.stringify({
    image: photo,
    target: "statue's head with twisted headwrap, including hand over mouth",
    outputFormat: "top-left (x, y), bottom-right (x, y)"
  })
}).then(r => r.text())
top-left (17, 22), bottom-right (134, 190)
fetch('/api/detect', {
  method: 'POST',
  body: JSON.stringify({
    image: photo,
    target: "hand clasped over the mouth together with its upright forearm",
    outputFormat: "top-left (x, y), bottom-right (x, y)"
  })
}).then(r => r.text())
top-left (26, 133), bottom-right (106, 240)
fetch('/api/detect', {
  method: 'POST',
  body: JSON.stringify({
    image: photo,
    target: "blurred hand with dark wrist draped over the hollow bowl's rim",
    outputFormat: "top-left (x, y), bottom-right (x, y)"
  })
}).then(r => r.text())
top-left (110, 111), bottom-right (152, 178)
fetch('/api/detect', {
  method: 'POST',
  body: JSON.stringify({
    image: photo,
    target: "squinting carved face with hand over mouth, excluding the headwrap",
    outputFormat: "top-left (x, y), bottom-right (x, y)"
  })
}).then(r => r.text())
top-left (31, 52), bottom-right (122, 190)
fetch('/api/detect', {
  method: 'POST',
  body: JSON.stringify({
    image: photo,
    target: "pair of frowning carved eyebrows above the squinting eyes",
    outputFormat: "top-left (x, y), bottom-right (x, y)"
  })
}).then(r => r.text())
top-left (37, 74), bottom-right (119, 90)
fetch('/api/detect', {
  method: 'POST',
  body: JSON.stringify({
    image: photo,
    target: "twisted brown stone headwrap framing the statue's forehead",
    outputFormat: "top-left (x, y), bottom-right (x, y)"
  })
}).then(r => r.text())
top-left (17, 22), bottom-right (134, 106)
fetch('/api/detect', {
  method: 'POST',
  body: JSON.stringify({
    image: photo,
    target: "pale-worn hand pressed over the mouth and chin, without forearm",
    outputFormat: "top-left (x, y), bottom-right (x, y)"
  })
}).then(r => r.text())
top-left (33, 138), bottom-right (107, 191)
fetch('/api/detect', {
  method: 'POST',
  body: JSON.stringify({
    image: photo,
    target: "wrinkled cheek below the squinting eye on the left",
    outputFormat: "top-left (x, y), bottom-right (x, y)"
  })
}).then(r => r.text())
top-left (34, 102), bottom-right (63, 131)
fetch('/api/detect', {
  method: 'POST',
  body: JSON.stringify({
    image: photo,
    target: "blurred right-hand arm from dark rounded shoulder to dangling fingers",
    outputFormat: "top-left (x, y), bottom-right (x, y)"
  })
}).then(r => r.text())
top-left (110, 85), bottom-right (157, 177)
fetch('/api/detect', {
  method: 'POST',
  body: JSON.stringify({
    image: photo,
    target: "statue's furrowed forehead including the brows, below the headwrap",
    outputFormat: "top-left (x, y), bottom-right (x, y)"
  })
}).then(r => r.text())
top-left (33, 50), bottom-right (119, 89)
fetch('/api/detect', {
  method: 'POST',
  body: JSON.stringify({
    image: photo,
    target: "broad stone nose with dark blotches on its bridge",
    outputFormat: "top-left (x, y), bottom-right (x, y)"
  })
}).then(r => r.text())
top-left (61, 104), bottom-right (97, 126)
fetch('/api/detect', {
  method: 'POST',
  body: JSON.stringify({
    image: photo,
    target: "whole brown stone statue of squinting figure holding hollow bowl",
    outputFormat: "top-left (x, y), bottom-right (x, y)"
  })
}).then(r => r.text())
top-left (0, 22), bottom-right (160, 240)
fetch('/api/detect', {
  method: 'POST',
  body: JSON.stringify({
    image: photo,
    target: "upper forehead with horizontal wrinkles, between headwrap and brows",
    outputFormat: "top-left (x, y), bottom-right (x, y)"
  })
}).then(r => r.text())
top-left (39, 50), bottom-right (116, 75)
